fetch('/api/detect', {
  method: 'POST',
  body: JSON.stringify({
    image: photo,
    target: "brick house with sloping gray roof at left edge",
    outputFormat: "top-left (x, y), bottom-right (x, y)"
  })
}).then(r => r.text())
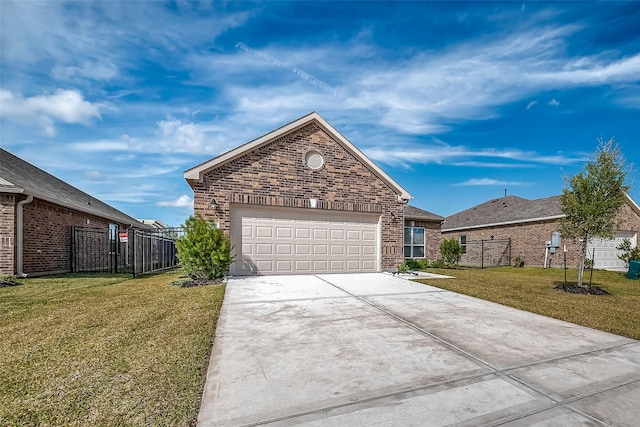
top-left (0, 149), bottom-right (147, 276)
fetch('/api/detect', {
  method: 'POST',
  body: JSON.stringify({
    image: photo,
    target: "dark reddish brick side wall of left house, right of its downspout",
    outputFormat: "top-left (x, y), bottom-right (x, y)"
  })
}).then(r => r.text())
top-left (23, 199), bottom-right (124, 274)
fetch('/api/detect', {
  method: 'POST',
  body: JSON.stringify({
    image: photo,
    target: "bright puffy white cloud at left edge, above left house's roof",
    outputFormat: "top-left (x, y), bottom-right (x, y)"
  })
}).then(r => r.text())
top-left (0, 89), bottom-right (108, 135)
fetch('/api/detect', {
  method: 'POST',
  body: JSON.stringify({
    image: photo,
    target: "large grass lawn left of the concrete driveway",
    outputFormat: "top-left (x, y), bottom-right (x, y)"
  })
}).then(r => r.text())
top-left (0, 272), bottom-right (224, 426)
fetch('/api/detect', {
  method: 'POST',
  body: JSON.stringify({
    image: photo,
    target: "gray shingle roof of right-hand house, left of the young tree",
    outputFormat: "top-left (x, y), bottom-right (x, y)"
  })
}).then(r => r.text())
top-left (442, 196), bottom-right (563, 231)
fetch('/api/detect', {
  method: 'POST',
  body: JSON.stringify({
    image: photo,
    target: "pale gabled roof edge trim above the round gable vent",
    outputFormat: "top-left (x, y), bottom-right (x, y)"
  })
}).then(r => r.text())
top-left (184, 111), bottom-right (412, 200)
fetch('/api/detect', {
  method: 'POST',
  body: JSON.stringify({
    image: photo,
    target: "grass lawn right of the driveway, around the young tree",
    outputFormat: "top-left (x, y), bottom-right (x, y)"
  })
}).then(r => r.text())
top-left (419, 267), bottom-right (640, 340)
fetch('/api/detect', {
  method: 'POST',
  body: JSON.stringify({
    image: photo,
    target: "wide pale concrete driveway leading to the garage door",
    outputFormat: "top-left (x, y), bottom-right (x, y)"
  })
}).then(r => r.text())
top-left (198, 273), bottom-right (640, 427)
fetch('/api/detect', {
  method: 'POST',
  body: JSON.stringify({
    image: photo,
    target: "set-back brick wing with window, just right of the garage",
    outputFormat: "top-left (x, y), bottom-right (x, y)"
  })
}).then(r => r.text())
top-left (404, 205), bottom-right (444, 261)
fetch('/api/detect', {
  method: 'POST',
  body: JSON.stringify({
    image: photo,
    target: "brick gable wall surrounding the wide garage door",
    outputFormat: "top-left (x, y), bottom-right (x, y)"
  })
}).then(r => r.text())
top-left (194, 123), bottom-right (403, 268)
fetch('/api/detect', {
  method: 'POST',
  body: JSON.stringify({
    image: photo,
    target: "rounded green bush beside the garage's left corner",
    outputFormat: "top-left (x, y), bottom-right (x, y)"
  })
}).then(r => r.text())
top-left (176, 216), bottom-right (233, 280)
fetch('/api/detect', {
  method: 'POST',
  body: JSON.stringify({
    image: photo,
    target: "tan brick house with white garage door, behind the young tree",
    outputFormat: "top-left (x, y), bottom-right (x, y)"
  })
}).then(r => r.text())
top-left (442, 196), bottom-right (640, 269)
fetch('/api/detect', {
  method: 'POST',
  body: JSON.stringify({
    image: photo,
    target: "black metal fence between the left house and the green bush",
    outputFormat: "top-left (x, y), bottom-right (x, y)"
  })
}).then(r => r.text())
top-left (71, 226), bottom-right (184, 277)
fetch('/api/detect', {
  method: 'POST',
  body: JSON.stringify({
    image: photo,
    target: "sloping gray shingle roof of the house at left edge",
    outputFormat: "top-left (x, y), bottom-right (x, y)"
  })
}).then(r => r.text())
top-left (0, 148), bottom-right (147, 228)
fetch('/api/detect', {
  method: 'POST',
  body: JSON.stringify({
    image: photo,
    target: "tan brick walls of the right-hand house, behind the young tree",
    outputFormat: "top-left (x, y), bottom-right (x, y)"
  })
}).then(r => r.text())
top-left (442, 205), bottom-right (640, 267)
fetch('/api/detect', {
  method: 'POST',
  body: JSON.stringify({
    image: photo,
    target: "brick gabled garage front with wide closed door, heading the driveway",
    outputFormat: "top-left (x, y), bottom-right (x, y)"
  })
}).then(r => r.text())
top-left (184, 112), bottom-right (411, 275)
